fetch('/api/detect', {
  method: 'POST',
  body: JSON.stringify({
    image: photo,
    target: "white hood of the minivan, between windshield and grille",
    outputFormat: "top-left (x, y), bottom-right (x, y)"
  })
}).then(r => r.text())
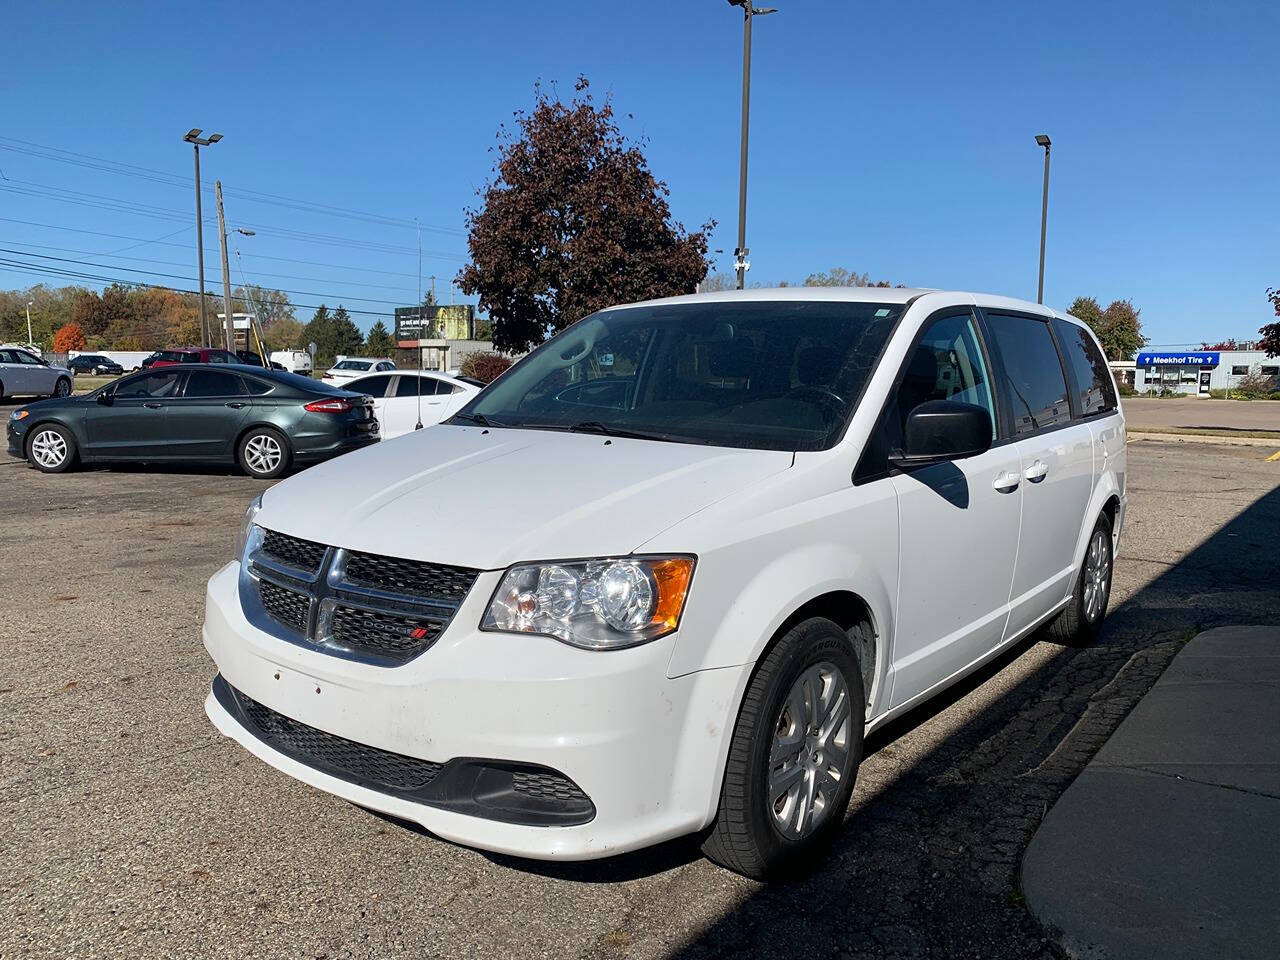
top-left (257, 425), bottom-right (794, 570)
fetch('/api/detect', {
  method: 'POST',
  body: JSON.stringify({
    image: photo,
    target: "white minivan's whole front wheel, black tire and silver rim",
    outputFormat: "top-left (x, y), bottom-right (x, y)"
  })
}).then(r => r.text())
top-left (703, 617), bottom-right (870, 879)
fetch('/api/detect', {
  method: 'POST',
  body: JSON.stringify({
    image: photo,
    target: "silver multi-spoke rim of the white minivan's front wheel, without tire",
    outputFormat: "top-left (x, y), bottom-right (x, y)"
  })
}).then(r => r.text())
top-left (767, 662), bottom-right (851, 840)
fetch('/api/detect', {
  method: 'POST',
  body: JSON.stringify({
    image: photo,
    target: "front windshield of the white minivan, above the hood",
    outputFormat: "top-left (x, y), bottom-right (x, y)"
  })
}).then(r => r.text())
top-left (449, 301), bottom-right (905, 451)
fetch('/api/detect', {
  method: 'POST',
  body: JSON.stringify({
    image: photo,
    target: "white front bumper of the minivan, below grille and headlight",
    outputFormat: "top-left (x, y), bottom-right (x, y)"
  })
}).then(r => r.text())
top-left (204, 562), bottom-right (749, 860)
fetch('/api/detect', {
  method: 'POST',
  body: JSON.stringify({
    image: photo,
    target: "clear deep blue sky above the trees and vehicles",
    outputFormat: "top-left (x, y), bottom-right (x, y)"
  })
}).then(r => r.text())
top-left (0, 0), bottom-right (1280, 344)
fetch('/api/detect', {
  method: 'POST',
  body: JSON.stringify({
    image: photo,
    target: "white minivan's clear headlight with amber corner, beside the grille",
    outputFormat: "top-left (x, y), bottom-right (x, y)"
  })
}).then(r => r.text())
top-left (480, 557), bottom-right (694, 650)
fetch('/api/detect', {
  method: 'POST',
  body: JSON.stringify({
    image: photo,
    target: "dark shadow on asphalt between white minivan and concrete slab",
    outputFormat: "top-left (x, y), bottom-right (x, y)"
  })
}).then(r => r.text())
top-left (650, 489), bottom-right (1280, 960)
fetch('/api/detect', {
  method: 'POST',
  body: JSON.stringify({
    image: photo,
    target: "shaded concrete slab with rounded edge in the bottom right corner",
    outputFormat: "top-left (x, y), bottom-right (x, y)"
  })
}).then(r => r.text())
top-left (1021, 627), bottom-right (1280, 960)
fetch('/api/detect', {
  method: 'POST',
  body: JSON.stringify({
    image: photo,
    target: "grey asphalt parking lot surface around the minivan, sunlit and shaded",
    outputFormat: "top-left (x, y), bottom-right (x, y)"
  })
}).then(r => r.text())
top-left (0, 440), bottom-right (1280, 957)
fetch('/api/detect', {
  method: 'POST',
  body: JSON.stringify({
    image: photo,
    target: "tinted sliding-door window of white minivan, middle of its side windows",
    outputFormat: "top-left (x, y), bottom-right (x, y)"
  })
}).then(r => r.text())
top-left (987, 314), bottom-right (1071, 436)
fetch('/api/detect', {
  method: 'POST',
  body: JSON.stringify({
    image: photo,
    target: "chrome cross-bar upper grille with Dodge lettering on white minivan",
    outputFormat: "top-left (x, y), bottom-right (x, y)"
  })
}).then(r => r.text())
top-left (239, 527), bottom-right (480, 666)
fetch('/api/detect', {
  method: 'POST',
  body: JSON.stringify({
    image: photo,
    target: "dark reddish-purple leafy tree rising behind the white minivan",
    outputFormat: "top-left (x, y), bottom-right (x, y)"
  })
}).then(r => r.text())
top-left (457, 77), bottom-right (714, 351)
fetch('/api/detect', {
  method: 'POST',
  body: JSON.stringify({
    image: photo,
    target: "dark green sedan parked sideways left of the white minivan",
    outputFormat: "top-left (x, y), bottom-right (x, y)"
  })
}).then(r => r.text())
top-left (8, 364), bottom-right (379, 480)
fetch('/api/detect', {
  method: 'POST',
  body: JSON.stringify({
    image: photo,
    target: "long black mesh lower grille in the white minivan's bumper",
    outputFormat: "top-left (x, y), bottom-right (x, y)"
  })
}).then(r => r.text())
top-left (224, 681), bottom-right (444, 792)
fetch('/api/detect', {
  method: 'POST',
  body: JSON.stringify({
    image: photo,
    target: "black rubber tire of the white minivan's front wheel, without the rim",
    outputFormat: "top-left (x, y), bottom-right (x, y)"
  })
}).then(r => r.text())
top-left (703, 617), bottom-right (872, 879)
